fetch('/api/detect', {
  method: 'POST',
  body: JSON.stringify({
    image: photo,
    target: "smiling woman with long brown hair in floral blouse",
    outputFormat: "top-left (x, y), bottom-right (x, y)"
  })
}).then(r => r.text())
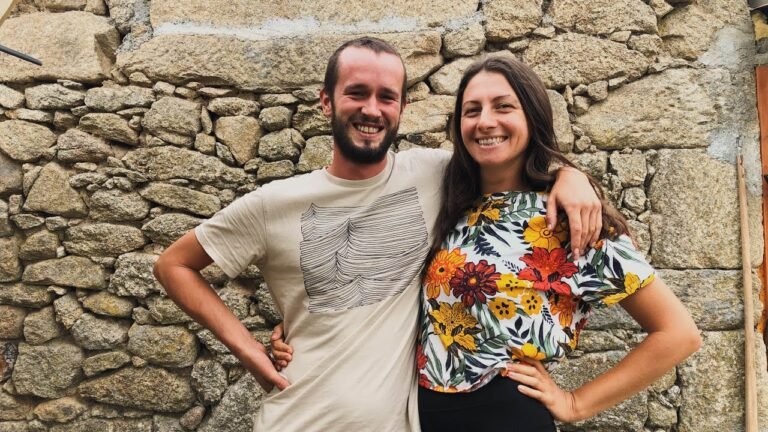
top-left (417, 57), bottom-right (701, 432)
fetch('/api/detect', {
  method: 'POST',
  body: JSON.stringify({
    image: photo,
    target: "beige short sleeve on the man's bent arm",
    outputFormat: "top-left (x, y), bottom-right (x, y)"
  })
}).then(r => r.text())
top-left (195, 190), bottom-right (267, 278)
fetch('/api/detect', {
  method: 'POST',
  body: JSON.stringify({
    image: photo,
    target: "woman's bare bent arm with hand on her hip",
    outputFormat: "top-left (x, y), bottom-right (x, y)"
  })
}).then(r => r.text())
top-left (507, 277), bottom-right (701, 423)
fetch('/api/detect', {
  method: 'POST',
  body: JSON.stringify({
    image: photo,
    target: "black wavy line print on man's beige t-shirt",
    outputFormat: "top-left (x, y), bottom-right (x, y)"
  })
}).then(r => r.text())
top-left (301, 188), bottom-right (429, 313)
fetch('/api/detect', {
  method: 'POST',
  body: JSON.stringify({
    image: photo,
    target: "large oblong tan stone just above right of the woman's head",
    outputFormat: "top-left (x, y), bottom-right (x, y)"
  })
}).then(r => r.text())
top-left (523, 33), bottom-right (649, 89)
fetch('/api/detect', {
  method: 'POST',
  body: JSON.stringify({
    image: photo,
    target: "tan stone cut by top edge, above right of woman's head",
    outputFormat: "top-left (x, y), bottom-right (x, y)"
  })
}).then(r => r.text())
top-left (549, 0), bottom-right (656, 35)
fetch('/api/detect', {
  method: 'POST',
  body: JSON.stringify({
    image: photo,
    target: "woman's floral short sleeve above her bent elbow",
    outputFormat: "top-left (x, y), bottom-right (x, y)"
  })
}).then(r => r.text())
top-left (571, 235), bottom-right (656, 307)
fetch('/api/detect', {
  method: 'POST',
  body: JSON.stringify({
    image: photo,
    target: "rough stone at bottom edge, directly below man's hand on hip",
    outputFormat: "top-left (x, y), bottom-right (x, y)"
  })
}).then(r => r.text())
top-left (197, 373), bottom-right (264, 432)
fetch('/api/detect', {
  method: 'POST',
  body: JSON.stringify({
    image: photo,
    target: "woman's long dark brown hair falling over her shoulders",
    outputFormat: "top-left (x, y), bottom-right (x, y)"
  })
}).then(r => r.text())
top-left (427, 57), bottom-right (629, 265)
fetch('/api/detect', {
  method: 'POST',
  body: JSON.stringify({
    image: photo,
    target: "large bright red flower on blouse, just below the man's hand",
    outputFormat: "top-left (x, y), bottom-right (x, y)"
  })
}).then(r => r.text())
top-left (517, 247), bottom-right (579, 295)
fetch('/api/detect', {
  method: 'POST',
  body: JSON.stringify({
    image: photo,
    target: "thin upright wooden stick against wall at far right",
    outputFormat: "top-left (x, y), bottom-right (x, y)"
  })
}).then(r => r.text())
top-left (736, 153), bottom-right (758, 432)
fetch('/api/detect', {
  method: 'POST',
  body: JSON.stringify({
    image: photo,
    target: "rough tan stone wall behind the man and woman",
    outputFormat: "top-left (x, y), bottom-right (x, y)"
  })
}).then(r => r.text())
top-left (0, 0), bottom-right (768, 432)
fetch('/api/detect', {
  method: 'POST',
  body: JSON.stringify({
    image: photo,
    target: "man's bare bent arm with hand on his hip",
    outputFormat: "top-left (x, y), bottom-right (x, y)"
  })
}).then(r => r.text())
top-left (154, 230), bottom-right (289, 390)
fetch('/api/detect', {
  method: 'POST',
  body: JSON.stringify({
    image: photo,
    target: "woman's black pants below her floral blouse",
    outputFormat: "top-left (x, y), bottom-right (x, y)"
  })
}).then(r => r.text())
top-left (419, 376), bottom-right (556, 432)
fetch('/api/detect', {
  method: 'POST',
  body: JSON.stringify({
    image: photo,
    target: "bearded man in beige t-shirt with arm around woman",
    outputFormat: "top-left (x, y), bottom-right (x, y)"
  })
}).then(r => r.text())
top-left (155, 38), bottom-right (599, 432)
